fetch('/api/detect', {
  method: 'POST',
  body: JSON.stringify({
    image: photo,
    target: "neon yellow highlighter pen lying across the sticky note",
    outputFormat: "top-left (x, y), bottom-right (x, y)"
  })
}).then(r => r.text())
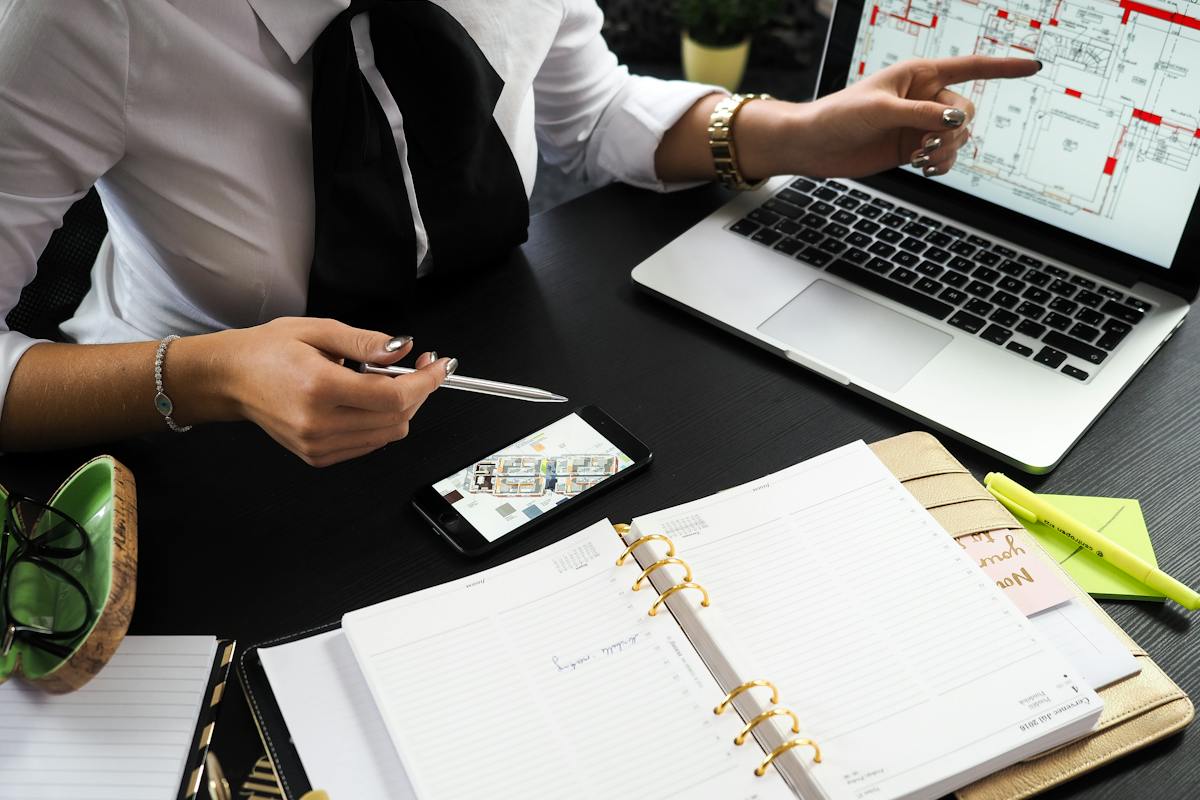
top-left (984, 473), bottom-right (1200, 610)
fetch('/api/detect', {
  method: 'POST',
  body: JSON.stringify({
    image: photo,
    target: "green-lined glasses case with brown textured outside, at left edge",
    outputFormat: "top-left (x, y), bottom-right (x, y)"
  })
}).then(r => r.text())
top-left (0, 456), bottom-right (137, 692)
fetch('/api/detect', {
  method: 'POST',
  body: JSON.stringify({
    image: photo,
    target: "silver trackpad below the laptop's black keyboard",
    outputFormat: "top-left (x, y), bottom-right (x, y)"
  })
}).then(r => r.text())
top-left (758, 281), bottom-right (954, 391)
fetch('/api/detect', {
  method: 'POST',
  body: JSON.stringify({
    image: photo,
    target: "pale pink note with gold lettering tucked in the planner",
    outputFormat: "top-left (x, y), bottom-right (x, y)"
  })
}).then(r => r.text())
top-left (956, 530), bottom-right (1072, 616)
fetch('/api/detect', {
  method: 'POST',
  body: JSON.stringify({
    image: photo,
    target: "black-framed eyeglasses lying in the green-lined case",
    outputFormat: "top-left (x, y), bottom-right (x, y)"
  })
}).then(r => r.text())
top-left (0, 494), bottom-right (96, 658)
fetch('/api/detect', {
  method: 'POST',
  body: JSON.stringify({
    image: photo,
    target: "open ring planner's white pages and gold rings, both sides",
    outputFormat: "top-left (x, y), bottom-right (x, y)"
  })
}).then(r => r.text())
top-left (242, 443), bottom-right (1136, 800)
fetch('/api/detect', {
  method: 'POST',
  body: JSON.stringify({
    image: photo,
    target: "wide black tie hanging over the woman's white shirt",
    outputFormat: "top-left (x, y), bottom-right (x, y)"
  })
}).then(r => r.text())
top-left (307, 0), bottom-right (529, 333)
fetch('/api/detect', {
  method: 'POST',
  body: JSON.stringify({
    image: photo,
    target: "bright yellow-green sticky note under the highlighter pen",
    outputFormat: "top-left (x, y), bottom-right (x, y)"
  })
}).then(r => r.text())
top-left (1024, 494), bottom-right (1164, 600)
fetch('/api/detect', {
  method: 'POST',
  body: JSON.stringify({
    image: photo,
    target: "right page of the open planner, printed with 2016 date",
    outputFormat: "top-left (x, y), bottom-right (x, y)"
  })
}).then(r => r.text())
top-left (630, 443), bottom-right (1102, 800)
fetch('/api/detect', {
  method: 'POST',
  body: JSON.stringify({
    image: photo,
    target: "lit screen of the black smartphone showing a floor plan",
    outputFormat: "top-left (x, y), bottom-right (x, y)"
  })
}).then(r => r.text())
top-left (433, 414), bottom-right (634, 542)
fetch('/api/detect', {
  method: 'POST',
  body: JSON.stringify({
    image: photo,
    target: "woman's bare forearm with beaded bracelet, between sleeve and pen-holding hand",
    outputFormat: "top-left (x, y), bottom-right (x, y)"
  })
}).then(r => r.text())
top-left (0, 333), bottom-right (235, 451)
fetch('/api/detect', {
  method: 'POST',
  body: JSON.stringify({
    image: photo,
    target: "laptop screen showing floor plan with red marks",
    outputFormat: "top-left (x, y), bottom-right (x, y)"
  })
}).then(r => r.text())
top-left (840, 0), bottom-right (1200, 267)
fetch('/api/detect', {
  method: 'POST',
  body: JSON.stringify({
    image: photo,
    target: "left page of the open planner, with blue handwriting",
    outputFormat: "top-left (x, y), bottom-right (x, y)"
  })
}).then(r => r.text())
top-left (342, 522), bottom-right (792, 800)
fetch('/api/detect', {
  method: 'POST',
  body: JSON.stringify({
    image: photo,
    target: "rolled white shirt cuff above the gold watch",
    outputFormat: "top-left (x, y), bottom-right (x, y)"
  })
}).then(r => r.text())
top-left (588, 76), bottom-right (728, 192)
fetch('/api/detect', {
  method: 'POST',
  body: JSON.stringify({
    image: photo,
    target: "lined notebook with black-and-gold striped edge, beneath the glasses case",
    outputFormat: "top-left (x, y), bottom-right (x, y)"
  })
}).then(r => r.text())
top-left (0, 636), bottom-right (234, 800)
